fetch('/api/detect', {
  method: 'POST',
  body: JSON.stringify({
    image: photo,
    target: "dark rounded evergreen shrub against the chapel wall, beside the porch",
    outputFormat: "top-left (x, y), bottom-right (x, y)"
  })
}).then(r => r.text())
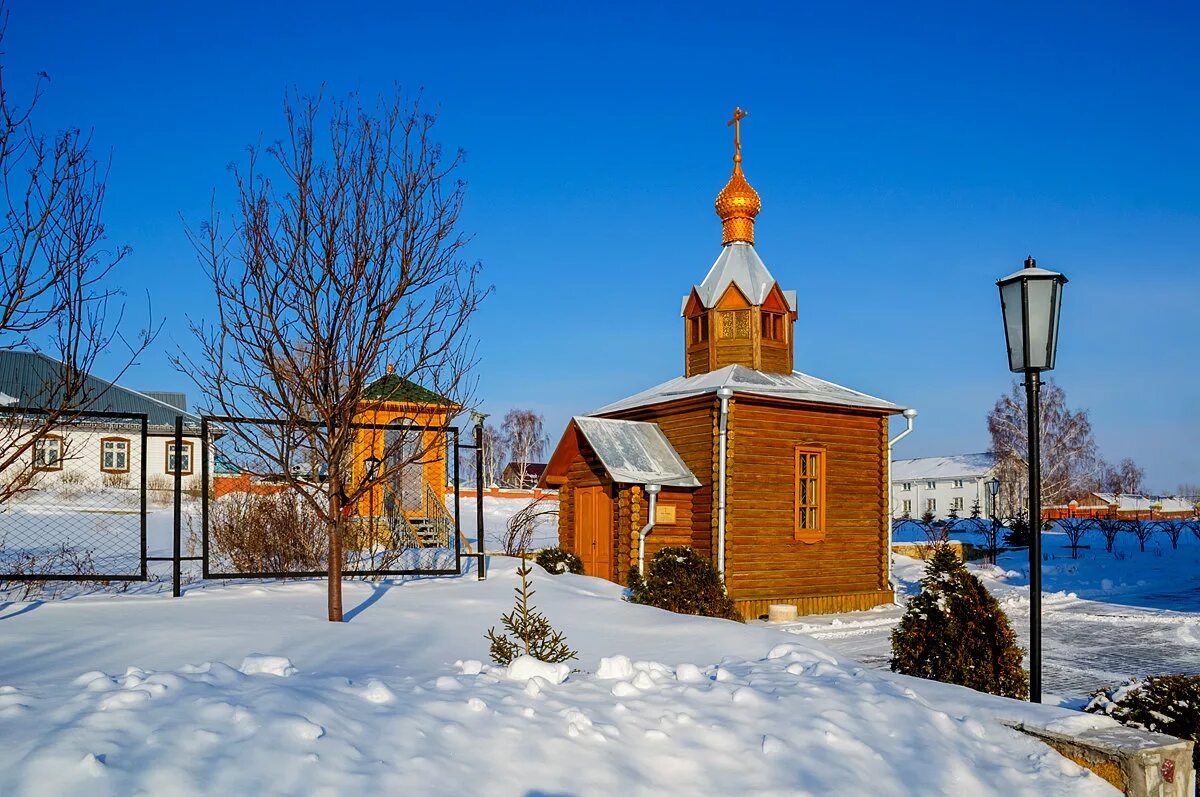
top-left (628, 545), bottom-right (742, 622)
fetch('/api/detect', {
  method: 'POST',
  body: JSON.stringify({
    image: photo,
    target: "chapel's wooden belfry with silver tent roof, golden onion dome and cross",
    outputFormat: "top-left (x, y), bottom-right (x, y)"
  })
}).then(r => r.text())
top-left (683, 108), bottom-right (796, 377)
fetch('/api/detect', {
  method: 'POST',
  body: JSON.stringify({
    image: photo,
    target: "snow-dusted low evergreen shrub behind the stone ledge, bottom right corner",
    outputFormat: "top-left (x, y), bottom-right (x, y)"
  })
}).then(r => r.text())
top-left (1084, 676), bottom-right (1200, 795)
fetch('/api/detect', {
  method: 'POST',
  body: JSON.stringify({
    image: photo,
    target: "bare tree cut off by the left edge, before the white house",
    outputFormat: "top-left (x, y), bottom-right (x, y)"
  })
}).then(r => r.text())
top-left (0, 2), bottom-right (154, 504)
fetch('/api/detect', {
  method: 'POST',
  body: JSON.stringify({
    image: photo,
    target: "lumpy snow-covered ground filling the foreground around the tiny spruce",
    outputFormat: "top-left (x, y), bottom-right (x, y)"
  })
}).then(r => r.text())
top-left (0, 558), bottom-right (1115, 797)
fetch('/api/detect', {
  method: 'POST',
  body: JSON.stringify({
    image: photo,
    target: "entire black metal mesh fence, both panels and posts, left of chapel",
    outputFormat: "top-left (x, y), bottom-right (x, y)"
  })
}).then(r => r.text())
top-left (0, 407), bottom-right (486, 595)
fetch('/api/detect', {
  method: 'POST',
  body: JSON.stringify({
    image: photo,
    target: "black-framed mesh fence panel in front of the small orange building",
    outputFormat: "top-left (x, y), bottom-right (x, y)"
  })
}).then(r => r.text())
top-left (200, 415), bottom-right (484, 579)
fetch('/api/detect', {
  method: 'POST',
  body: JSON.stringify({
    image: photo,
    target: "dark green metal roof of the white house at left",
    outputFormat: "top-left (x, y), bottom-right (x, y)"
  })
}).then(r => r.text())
top-left (0, 350), bottom-right (200, 426)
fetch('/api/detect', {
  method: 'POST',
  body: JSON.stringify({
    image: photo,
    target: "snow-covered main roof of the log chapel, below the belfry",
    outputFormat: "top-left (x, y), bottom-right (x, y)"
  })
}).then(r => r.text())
top-left (588, 364), bottom-right (904, 415)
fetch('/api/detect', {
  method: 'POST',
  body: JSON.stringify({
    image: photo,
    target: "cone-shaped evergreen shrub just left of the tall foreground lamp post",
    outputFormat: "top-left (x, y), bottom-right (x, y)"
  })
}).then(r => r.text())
top-left (892, 545), bottom-right (1028, 700)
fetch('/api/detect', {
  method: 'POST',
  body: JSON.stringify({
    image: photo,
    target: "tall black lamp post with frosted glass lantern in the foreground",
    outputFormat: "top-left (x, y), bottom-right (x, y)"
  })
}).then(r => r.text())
top-left (996, 257), bottom-right (1067, 703)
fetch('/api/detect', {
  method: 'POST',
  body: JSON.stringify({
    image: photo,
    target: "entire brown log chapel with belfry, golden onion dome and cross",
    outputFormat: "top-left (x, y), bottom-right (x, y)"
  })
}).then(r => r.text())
top-left (541, 108), bottom-right (902, 617)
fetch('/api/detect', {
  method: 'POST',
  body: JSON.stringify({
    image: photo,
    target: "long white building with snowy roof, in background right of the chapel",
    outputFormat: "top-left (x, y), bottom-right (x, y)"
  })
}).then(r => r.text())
top-left (892, 454), bottom-right (996, 520)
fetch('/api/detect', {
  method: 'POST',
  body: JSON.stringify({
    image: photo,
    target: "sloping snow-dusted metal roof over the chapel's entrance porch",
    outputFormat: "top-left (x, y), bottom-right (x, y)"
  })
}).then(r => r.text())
top-left (571, 417), bottom-right (700, 487)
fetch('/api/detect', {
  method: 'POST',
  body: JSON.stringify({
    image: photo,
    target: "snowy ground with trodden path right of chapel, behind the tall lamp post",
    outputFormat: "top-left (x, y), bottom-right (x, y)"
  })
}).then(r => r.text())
top-left (790, 532), bottom-right (1200, 705)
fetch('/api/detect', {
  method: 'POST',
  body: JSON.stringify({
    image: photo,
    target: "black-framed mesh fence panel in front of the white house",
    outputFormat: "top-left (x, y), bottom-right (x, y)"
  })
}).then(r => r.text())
top-left (0, 407), bottom-right (149, 581)
